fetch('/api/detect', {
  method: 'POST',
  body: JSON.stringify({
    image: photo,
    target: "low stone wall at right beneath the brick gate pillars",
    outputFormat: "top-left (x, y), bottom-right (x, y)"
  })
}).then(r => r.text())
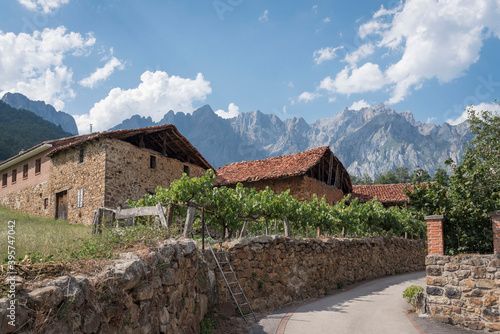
top-left (426, 255), bottom-right (500, 331)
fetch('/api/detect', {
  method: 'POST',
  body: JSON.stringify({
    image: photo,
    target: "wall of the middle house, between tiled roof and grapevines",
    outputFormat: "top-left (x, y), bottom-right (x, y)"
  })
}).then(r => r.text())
top-left (244, 176), bottom-right (344, 205)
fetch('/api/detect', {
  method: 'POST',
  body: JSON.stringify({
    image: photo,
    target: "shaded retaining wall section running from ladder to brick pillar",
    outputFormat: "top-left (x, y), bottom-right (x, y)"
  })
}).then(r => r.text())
top-left (212, 236), bottom-right (425, 311)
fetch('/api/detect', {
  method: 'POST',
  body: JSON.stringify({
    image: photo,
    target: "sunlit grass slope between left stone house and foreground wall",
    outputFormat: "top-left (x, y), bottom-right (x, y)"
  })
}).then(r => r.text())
top-left (0, 207), bottom-right (175, 264)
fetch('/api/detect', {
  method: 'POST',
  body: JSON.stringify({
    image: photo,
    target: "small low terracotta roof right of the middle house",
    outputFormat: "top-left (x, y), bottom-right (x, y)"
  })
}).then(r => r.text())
top-left (352, 183), bottom-right (411, 205)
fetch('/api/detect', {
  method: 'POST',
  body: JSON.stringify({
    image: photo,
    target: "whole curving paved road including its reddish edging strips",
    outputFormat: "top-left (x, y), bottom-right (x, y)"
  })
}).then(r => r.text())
top-left (249, 271), bottom-right (471, 334)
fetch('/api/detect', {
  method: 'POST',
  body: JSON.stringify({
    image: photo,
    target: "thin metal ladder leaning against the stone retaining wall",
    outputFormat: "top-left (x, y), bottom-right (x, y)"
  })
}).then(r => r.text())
top-left (208, 241), bottom-right (257, 325)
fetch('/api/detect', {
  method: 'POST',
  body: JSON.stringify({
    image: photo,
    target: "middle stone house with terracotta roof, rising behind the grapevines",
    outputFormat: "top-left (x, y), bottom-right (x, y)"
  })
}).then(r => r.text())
top-left (216, 146), bottom-right (352, 205)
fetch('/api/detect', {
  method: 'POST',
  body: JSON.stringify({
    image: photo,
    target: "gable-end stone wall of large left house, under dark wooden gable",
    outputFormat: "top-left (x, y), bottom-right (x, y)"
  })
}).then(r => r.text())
top-left (104, 139), bottom-right (206, 208)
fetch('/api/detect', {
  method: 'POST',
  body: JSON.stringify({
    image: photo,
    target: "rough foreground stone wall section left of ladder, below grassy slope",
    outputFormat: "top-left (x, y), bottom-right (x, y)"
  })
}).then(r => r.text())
top-left (0, 239), bottom-right (215, 334)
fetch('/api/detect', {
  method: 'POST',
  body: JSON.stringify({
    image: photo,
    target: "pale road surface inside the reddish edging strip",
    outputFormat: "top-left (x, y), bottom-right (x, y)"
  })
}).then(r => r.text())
top-left (285, 272), bottom-right (425, 334)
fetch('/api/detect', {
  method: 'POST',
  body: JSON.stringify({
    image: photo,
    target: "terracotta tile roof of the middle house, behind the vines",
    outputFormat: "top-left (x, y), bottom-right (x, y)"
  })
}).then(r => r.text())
top-left (217, 146), bottom-right (351, 190)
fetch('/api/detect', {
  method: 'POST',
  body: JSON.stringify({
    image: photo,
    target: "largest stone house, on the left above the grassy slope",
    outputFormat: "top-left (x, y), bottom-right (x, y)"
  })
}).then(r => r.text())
top-left (0, 124), bottom-right (213, 225)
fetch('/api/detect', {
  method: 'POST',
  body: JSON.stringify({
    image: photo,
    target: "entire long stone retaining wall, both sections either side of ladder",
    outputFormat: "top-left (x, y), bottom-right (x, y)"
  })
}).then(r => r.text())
top-left (0, 236), bottom-right (425, 334)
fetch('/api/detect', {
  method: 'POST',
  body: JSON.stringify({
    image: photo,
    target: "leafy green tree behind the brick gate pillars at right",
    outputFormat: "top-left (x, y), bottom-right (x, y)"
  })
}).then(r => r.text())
top-left (408, 105), bottom-right (500, 254)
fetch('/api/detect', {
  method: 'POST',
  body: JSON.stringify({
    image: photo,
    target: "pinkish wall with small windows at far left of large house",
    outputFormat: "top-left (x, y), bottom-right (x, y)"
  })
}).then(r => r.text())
top-left (0, 153), bottom-right (53, 217)
